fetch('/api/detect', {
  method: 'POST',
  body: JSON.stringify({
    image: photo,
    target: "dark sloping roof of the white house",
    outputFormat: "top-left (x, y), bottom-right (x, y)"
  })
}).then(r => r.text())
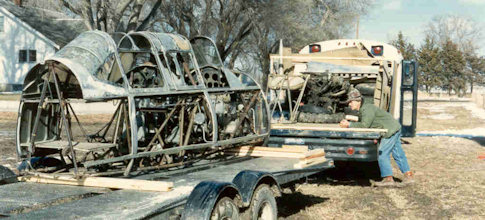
top-left (0, 0), bottom-right (88, 47)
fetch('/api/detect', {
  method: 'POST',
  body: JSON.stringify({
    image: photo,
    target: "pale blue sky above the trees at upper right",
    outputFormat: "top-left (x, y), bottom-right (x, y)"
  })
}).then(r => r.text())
top-left (356, 0), bottom-right (485, 55)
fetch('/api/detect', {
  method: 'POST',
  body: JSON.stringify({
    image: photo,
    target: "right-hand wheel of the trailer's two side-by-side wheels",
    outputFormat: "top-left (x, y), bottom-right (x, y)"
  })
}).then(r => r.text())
top-left (249, 184), bottom-right (278, 220)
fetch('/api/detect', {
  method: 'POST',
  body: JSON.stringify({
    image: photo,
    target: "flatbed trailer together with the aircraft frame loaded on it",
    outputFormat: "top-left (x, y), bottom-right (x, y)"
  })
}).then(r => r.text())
top-left (0, 31), bottom-right (333, 219)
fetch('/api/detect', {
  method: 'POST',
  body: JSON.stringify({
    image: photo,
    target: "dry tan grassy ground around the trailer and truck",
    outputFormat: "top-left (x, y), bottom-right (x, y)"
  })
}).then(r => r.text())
top-left (0, 102), bottom-right (485, 219)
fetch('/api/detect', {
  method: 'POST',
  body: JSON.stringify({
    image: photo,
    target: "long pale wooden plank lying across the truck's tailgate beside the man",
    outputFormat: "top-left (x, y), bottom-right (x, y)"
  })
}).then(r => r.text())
top-left (271, 123), bottom-right (387, 133)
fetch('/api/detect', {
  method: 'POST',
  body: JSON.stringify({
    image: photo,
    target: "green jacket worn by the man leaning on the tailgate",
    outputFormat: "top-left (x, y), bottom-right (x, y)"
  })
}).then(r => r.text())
top-left (350, 104), bottom-right (401, 138)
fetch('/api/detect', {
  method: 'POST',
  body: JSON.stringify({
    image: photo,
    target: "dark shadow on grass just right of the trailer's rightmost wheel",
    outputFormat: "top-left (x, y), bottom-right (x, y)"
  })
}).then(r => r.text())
top-left (276, 192), bottom-right (330, 218)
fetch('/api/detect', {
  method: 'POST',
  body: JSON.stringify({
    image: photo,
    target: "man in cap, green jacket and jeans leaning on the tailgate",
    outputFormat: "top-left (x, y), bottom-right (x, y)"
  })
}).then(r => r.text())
top-left (340, 89), bottom-right (414, 186)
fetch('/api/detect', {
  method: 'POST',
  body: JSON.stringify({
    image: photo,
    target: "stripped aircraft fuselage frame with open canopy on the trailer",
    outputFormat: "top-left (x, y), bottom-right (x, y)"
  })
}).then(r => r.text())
top-left (16, 31), bottom-right (269, 175)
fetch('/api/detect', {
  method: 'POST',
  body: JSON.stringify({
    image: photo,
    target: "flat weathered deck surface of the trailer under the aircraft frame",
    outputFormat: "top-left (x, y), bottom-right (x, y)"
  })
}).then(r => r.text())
top-left (0, 158), bottom-right (331, 219)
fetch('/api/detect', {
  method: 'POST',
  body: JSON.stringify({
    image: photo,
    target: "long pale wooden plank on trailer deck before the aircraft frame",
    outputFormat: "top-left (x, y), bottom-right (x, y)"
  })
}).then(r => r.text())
top-left (18, 174), bottom-right (173, 192)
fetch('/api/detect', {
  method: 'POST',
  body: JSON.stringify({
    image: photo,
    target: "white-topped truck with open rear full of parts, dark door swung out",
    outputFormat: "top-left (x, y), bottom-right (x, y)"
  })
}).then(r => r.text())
top-left (267, 39), bottom-right (417, 164)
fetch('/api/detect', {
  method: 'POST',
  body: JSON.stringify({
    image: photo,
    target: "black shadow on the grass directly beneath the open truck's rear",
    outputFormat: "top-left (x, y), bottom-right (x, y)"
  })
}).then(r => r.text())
top-left (308, 161), bottom-right (381, 186)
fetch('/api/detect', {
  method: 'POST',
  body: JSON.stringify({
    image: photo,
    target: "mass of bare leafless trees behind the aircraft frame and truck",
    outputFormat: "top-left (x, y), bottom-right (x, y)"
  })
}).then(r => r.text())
top-left (24, 0), bottom-right (373, 82)
